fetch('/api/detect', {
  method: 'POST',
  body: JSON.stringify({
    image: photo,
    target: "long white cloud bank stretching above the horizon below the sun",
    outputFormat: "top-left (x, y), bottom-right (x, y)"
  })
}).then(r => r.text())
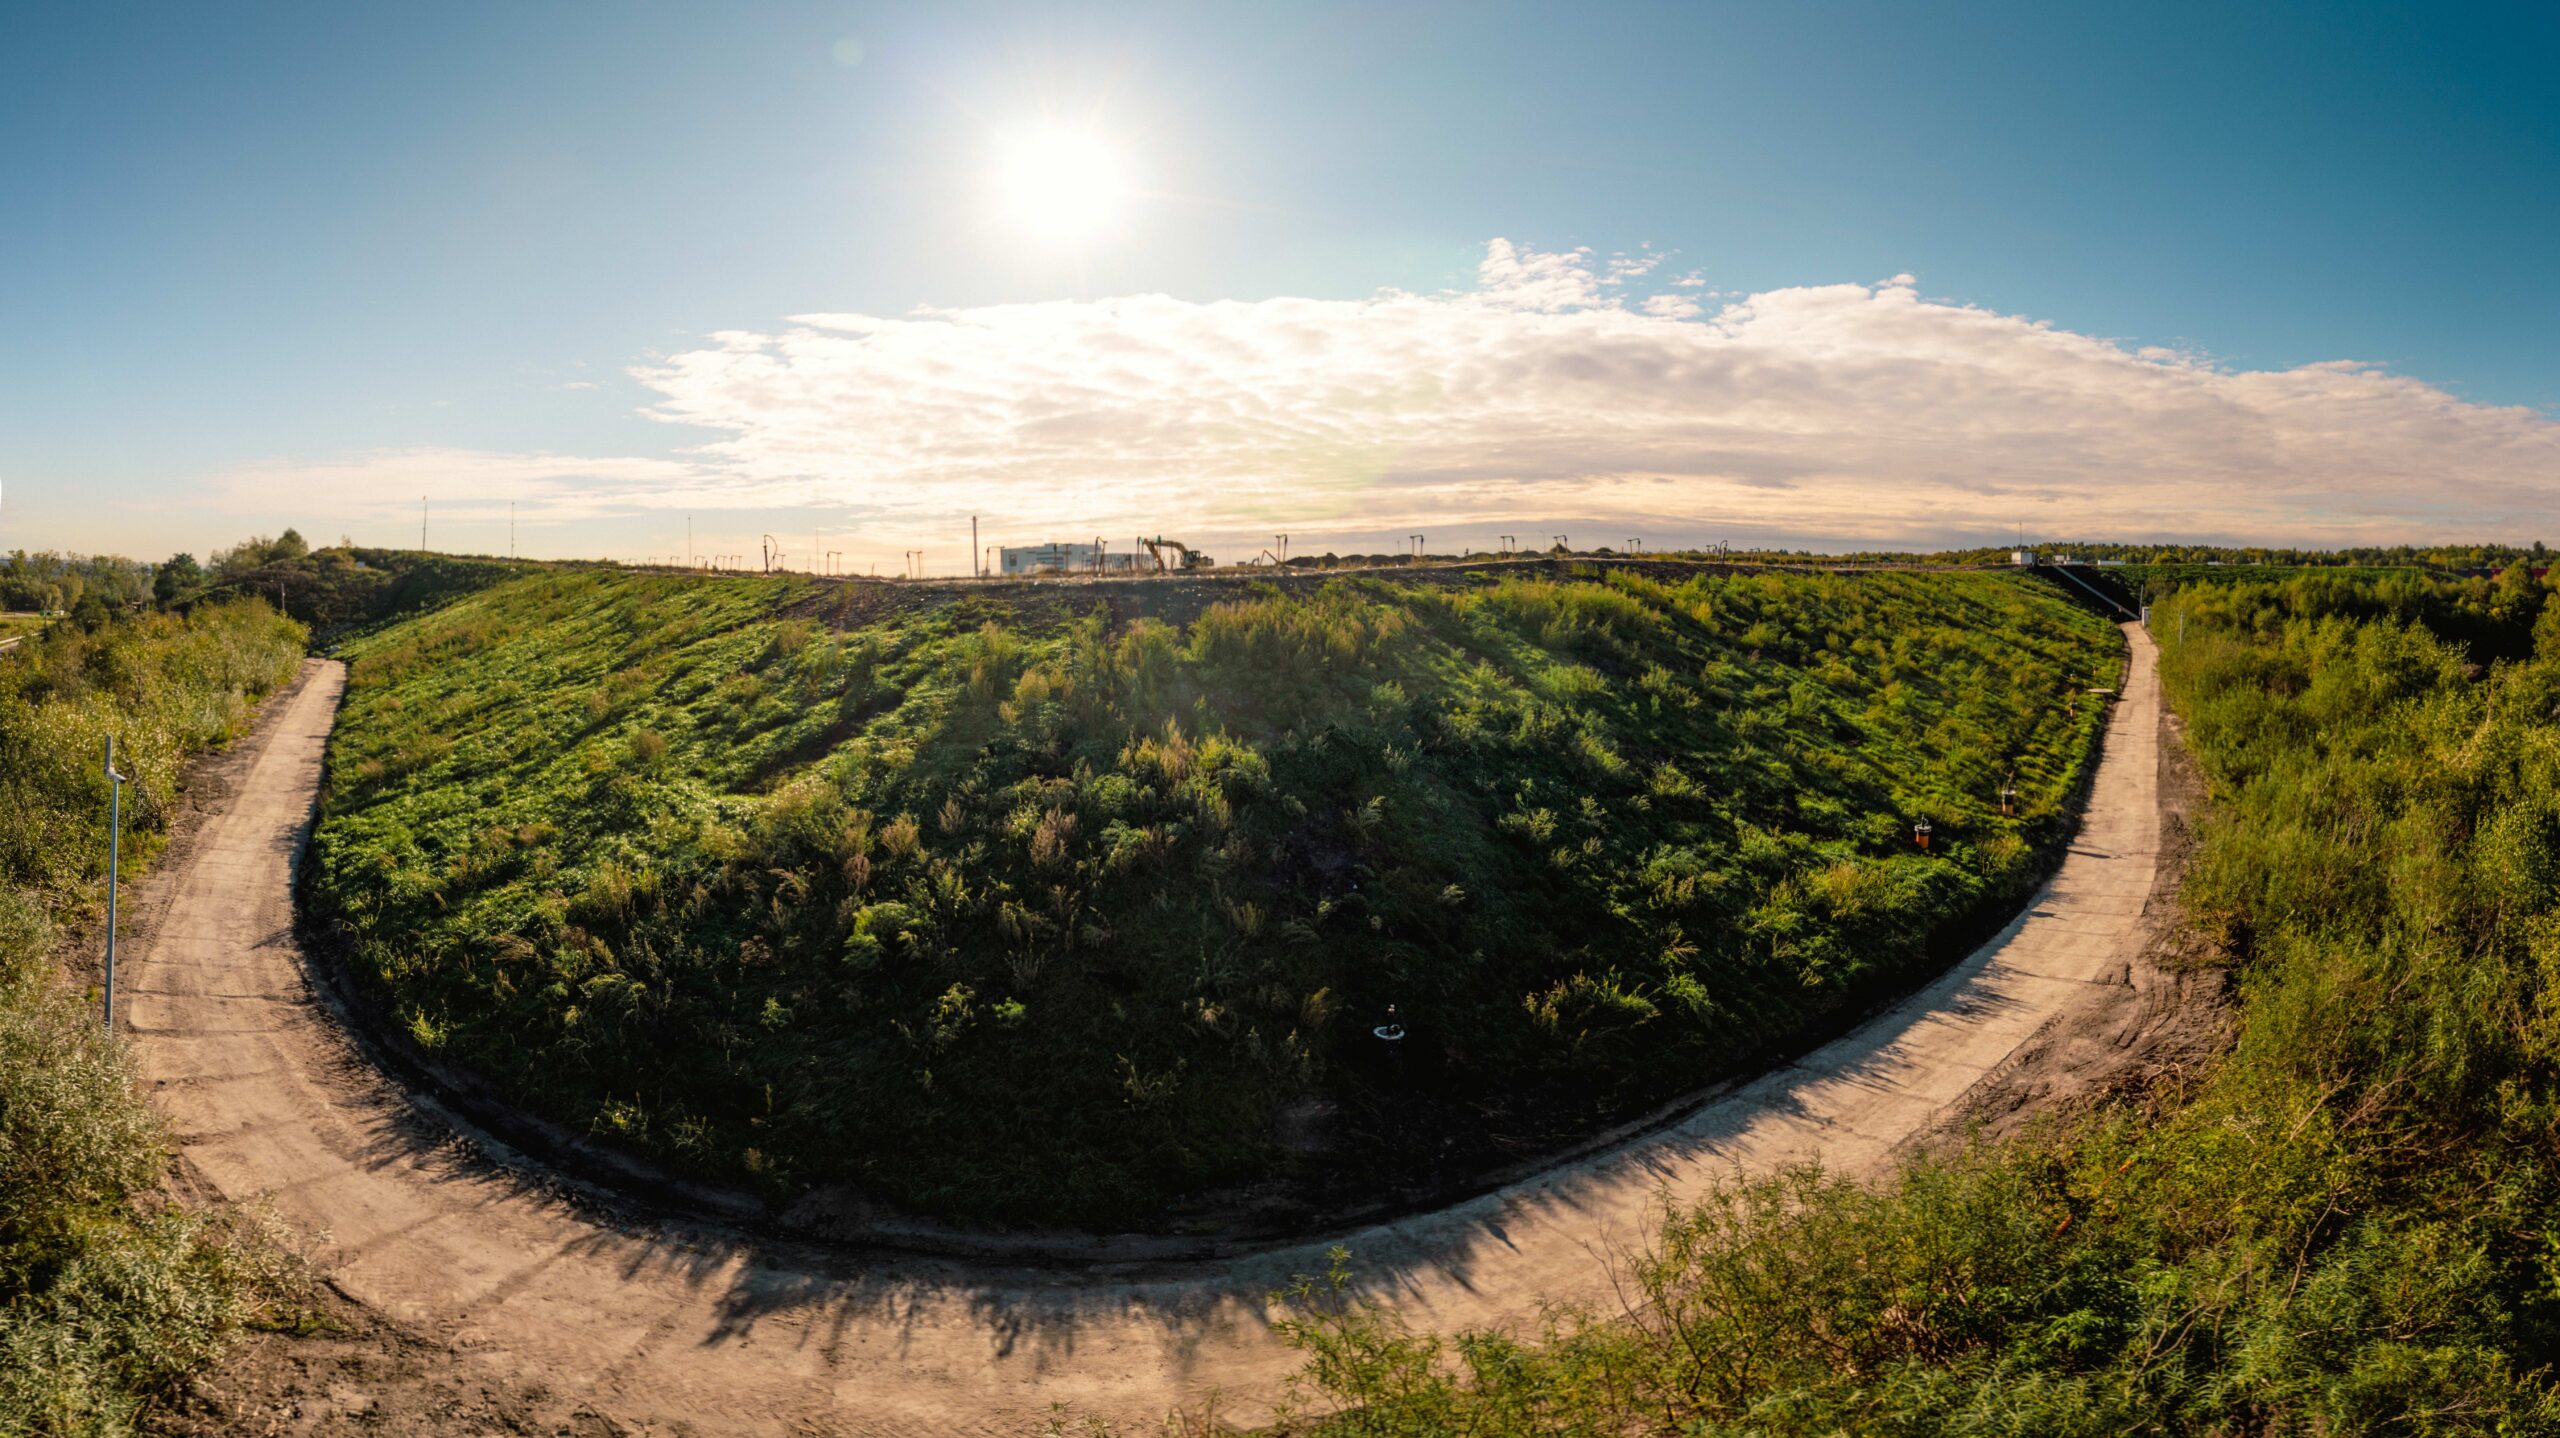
top-left (220, 241), bottom-right (2560, 545)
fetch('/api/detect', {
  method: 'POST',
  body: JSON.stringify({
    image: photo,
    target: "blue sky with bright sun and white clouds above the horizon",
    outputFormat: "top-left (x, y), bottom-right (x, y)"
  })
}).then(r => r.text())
top-left (0, 0), bottom-right (2560, 573)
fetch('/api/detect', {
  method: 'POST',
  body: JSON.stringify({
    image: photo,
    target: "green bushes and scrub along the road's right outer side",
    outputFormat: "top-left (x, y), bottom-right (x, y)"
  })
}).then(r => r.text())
top-left (1249, 571), bottom-right (2560, 1438)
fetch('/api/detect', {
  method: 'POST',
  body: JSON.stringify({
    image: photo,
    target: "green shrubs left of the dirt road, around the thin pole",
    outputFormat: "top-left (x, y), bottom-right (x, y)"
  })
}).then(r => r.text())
top-left (0, 593), bottom-right (302, 1435)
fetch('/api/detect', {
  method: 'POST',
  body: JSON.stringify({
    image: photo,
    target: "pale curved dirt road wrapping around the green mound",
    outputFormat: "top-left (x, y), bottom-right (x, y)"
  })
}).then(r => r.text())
top-left (125, 627), bottom-right (2158, 1433)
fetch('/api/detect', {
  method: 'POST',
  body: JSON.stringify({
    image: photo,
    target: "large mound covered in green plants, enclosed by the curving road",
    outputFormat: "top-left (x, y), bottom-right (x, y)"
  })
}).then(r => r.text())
top-left (312, 565), bottom-right (2122, 1226)
